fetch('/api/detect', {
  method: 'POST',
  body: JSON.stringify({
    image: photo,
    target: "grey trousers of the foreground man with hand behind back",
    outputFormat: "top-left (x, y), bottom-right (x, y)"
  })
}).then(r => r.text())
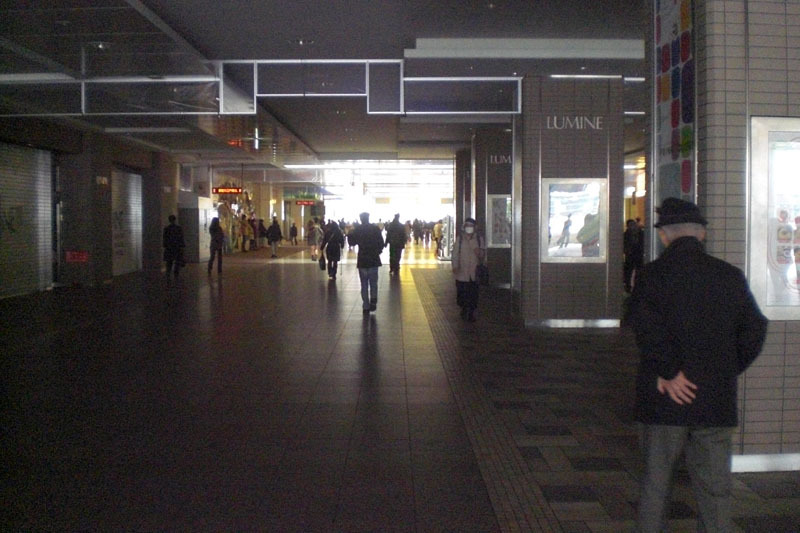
top-left (636, 425), bottom-right (733, 533)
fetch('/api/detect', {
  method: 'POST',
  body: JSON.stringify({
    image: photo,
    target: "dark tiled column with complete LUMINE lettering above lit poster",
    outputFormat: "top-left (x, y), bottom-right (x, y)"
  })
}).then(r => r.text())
top-left (521, 77), bottom-right (624, 325)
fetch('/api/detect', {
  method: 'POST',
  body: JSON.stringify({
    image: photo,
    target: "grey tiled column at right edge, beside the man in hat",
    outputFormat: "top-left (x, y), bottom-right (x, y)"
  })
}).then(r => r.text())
top-left (695, 0), bottom-right (800, 454)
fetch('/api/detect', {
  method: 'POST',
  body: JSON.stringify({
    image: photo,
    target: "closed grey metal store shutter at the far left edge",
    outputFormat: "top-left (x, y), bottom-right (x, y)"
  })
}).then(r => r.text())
top-left (0, 143), bottom-right (53, 298)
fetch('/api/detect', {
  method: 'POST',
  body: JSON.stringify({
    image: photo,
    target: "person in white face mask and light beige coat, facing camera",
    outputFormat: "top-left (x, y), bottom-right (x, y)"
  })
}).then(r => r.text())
top-left (452, 218), bottom-right (484, 322)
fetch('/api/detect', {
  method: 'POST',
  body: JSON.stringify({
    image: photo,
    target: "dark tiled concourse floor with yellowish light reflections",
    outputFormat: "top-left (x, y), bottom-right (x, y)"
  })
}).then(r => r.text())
top-left (0, 243), bottom-right (800, 532)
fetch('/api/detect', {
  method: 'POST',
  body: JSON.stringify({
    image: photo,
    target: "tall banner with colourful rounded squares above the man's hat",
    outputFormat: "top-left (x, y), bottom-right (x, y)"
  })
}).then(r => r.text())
top-left (653, 0), bottom-right (696, 204)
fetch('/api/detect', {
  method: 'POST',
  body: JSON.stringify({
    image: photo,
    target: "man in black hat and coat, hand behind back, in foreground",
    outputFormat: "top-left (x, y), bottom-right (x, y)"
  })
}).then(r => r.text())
top-left (628, 198), bottom-right (767, 532)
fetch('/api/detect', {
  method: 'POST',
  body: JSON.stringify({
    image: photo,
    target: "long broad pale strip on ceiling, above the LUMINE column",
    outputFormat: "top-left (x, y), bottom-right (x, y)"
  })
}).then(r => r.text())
top-left (403, 39), bottom-right (645, 59)
